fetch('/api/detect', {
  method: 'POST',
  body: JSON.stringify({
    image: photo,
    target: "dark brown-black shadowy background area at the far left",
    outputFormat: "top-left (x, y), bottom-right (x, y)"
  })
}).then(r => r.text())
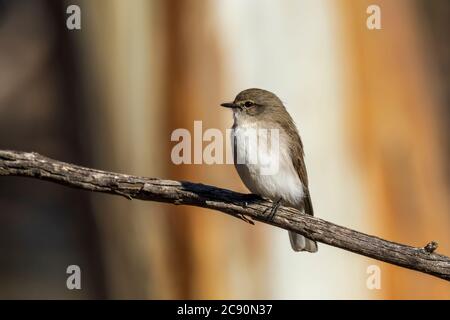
top-left (0, 0), bottom-right (106, 299)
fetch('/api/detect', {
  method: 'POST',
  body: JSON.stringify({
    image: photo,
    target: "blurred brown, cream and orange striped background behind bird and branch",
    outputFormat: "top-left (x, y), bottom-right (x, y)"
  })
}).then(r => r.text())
top-left (0, 0), bottom-right (450, 299)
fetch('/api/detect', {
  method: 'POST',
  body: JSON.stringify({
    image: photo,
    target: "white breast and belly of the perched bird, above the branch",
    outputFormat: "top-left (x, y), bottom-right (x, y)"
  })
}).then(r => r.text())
top-left (231, 123), bottom-right (304, 207)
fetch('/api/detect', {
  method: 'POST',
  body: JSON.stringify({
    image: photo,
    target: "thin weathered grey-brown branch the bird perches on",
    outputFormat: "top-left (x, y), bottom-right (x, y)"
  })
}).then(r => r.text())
top-left (0, 150), bottom-right (450, 281)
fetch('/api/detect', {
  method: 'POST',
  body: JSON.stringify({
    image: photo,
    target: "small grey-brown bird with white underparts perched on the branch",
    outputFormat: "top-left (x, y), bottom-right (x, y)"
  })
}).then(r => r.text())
top-left (221, 88), bottom-right (317, 252)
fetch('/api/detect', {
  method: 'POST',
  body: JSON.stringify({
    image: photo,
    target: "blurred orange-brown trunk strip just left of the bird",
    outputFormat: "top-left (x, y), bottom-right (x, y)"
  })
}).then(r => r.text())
top-left (163, 0), bottom-right (268, 299)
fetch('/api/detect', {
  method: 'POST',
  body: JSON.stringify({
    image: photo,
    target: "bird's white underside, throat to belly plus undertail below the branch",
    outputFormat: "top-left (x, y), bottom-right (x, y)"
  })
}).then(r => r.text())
top-left (231, 112), bottom-right (317, 252)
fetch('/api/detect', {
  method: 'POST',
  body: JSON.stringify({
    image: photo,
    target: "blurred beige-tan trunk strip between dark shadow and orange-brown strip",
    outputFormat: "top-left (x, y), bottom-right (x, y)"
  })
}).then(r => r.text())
top-left (79, 0), bottom-right (177, 299)
